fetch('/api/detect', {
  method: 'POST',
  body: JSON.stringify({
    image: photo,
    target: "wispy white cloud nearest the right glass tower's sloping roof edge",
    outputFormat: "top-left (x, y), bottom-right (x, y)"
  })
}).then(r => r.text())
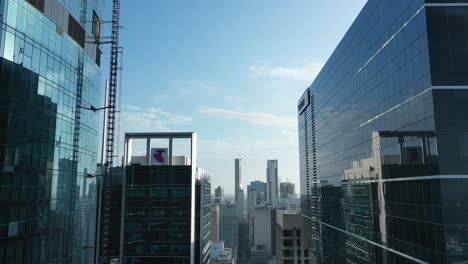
top-left (249, 62), bottom-right (323, 81)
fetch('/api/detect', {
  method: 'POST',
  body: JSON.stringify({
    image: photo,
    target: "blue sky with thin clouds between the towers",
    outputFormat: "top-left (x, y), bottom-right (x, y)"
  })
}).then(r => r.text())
top-left (103, 0), bottom-right (366, 193)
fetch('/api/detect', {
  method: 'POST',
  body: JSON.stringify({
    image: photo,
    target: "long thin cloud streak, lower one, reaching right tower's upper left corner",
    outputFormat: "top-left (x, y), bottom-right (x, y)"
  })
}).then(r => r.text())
top-left (200, 106), bottom-right (297, 129)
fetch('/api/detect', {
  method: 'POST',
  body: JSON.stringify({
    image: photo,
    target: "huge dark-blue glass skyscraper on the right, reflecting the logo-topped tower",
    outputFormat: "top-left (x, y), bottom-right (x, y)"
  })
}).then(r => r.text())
top-left (298, 0), bottom-right (468, 263)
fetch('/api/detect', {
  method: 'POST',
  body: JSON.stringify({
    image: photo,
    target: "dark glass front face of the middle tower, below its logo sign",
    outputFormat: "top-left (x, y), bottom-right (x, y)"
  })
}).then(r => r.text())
top-left (124, 165), bottom-right (192, 264)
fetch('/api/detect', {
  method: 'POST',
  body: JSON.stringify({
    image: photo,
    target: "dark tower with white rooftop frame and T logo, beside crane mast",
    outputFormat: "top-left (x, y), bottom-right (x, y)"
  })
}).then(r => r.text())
top-left (120, 132), bottom-right (211, 264)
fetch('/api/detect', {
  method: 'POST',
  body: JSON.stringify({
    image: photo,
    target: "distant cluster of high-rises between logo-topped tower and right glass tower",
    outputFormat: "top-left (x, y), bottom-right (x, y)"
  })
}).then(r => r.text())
top-left (211, 158), bottom-right (306, 264)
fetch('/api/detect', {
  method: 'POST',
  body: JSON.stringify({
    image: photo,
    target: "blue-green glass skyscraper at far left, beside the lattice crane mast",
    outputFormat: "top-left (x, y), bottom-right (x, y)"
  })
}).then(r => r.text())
top-left (0, 0), bottom-right (103, 263)
